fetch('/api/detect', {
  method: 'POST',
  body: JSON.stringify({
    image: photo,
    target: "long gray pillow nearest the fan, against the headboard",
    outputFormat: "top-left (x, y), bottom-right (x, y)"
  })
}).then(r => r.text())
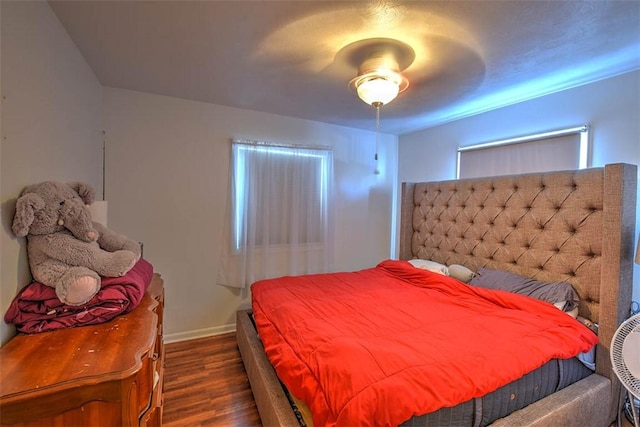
top-left (469, 267), bottom-right (580, 312)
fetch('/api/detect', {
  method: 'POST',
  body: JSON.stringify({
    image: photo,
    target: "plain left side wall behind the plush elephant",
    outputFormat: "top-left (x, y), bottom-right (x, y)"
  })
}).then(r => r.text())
top-left (0, 0), bottom-right (102, 343)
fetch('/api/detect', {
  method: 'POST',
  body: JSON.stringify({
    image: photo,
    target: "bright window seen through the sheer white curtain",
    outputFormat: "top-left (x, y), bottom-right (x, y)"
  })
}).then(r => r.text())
top-left (232, 143), bottom-right (330, 250)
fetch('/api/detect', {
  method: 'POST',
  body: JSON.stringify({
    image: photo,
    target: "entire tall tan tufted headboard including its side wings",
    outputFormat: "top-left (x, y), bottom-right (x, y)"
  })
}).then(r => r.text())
top-left (400, 163), bottom-right (637, 388)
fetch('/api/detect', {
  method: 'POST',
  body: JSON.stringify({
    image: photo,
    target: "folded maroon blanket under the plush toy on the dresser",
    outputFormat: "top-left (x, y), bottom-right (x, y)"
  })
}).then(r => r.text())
top-left (4, 259), bottom-right (153, 334)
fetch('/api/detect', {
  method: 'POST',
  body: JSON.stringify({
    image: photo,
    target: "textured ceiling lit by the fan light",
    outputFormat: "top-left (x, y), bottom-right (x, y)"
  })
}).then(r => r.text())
top-left (49, 0), bottom-right (640, 134)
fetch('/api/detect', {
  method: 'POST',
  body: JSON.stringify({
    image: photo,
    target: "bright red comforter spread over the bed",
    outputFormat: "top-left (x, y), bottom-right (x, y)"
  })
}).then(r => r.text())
top-left (251, 260), bottom-right (597, 426)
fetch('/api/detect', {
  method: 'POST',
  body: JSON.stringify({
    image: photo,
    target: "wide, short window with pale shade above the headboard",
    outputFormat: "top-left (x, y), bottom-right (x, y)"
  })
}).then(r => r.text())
top-left (457, 125), bottom-right (589, 178)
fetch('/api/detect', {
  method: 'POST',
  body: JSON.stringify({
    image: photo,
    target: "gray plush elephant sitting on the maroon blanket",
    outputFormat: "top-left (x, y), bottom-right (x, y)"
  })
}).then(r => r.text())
top-left (12, 181), bottom-right (141, 305)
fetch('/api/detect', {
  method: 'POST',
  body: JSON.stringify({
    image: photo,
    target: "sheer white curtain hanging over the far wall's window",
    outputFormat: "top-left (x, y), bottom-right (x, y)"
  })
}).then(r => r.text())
top-left (218, 140), bottom-right (333, 287)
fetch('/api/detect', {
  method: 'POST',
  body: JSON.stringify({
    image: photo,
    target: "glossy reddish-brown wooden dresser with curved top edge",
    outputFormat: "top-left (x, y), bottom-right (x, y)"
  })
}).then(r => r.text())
top-left (0, 274), bottom-right (164, 427)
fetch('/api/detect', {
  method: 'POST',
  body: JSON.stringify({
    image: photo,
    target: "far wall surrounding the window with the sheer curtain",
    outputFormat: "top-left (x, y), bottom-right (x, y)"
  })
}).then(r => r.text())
top-left (104, 88), bottom-right (397, 341)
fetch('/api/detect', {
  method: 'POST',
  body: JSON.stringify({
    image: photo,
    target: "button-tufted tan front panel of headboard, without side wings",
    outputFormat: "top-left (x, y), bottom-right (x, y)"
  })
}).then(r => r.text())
top-left (402, 169), bottom-right (636, 332)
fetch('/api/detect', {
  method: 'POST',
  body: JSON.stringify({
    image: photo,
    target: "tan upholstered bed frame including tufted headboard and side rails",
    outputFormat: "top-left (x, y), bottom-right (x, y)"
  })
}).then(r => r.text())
top-left (237, 164), bottom-right (637, 426)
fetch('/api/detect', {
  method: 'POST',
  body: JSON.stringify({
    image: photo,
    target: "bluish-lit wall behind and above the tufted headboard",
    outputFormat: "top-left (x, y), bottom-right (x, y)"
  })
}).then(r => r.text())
top-left (398, 71), bottom-right (640, 301)
